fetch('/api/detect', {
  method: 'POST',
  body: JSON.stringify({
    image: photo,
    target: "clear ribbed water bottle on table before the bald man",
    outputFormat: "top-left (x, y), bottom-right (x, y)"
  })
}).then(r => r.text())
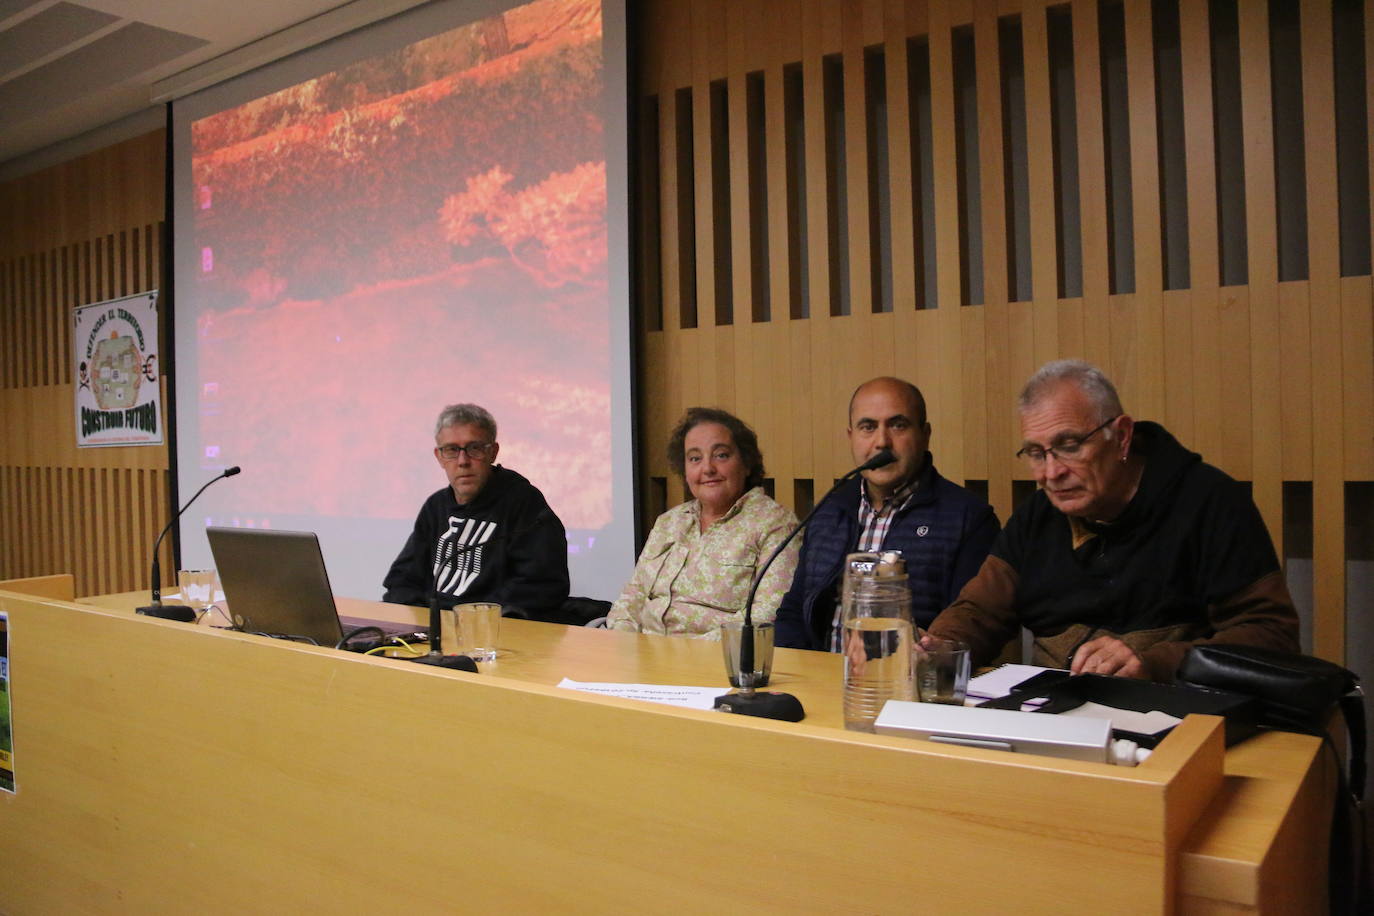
top-left (840, 552), bottom-right (915, 732)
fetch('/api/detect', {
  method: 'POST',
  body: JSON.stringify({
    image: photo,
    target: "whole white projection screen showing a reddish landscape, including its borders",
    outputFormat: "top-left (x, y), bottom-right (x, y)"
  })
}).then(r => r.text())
top-left (172, 0), bottom-right (635, 609)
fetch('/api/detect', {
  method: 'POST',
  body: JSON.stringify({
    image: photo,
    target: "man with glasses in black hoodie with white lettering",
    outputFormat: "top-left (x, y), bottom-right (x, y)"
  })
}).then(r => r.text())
top-left (382, 404), bottom-right (567, 619)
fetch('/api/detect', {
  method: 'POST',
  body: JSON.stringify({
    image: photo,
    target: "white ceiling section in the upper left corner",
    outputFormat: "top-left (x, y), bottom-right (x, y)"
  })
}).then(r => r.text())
top-left (0, 0), bottom-right (420, 166)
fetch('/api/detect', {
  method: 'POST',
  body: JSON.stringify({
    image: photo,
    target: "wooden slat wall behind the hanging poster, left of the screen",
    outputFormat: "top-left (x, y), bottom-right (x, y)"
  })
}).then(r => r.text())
top-left (0, 130), bottom-right (174, 596)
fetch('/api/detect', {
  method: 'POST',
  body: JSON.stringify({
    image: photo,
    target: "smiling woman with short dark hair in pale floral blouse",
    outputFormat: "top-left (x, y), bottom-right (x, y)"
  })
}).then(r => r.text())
top-left (607, 407), bottom-right (798, 639)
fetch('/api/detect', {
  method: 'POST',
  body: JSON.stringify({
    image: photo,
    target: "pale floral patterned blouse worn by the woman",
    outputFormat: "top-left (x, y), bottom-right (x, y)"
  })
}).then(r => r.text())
top-left (606, 486), bottom-right (800, 639)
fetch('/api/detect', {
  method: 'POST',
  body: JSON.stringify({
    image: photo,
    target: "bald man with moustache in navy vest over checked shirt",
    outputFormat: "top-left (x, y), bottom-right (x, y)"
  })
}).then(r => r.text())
top-left (776, 378), bottom-right (998, 651)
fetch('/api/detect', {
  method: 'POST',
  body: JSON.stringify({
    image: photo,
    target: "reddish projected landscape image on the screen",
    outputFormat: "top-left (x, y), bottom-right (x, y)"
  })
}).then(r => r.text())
top-left (190, 0), bottom-right (611, 530)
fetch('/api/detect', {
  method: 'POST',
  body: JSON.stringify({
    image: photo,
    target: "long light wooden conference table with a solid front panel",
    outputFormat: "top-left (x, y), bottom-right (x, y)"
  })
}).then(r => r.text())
top-left (0, 591), bottom-right (1334, 913)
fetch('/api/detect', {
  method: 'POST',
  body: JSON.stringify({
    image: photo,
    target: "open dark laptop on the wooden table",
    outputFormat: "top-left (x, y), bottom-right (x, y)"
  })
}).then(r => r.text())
top-left (205, 527), bottom-right (427, 648)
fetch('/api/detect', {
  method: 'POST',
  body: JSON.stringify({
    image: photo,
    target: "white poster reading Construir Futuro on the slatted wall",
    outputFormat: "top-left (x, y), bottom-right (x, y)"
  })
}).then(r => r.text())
top-left (71, 290), bottom-right (162, 448)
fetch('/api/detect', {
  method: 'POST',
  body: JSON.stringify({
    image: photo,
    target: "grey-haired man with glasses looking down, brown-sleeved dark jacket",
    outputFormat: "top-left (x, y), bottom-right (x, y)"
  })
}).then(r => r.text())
top-left (930, 360), bottom-right (1298, 681)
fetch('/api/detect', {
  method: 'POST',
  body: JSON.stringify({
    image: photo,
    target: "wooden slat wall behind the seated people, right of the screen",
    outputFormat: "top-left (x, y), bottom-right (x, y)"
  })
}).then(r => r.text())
top-left (638, 0), bottom-right (1374, 659)
